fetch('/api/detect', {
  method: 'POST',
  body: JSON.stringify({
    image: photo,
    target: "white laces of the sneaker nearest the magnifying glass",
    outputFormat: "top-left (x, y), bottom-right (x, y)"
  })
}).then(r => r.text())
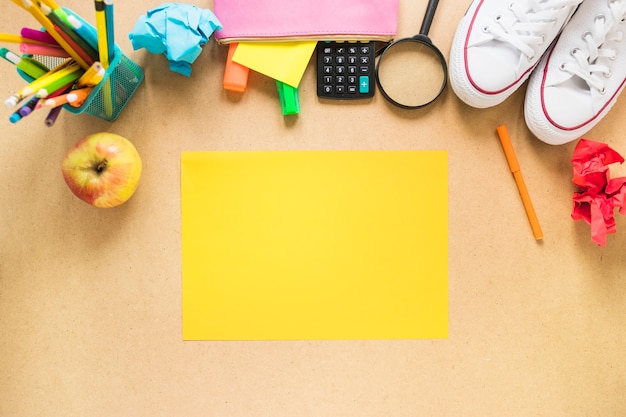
top-left (483, 0), bottom-right (579, 60)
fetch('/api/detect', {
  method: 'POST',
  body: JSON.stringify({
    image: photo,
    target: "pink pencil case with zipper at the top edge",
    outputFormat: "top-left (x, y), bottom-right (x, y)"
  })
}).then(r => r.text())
top-left (213, 0), bottom-right (399, 44)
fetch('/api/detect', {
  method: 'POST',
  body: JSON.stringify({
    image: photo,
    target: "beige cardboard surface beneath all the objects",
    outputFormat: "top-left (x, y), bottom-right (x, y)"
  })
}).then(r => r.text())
top-left (0, 0), bottom-right (626, 417)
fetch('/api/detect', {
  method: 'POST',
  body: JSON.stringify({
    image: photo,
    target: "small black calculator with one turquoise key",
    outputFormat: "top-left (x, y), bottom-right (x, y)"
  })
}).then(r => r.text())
top-left (317, 41), bottom-right (376, 100)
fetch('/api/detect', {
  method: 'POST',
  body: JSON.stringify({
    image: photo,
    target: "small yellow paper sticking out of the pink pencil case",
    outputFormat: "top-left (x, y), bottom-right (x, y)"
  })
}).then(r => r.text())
top-left (233, 41), bottom-right (317, 88)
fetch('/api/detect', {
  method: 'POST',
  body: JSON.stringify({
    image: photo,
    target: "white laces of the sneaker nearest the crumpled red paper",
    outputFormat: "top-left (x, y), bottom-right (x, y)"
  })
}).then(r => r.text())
top-left (561, 0), bottom-right (626, 94)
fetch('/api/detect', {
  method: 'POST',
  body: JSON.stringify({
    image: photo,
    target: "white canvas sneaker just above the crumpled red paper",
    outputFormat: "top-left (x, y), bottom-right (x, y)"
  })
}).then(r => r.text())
top-left (524, 0), bottom-right (626, 145)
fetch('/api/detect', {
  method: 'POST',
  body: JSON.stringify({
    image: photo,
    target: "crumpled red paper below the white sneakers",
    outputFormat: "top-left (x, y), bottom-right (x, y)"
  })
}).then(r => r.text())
top-left (572, 139), bottom-right (626, 246)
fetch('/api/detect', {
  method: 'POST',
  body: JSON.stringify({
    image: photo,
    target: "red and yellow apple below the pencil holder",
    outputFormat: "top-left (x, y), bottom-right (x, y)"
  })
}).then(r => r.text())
top-left (62, 132), bottom-right (141, 207)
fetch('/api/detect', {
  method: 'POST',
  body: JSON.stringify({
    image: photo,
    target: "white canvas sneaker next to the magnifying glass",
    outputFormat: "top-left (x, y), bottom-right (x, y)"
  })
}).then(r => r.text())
top-left (450, 0), bottom-right (582, 108)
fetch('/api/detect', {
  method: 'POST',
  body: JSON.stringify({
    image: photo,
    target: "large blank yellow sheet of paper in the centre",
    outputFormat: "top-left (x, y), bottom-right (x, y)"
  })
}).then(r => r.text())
top-left (181, 151), bottom-right (448, 340)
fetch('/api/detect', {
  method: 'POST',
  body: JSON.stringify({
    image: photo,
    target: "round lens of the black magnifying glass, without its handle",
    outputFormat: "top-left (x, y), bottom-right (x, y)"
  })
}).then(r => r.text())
top-left (378, 40), bottom-right (447, 107)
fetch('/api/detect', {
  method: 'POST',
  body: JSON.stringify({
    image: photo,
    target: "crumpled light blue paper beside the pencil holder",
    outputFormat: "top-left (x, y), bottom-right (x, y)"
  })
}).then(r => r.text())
top-left (128, 3), bottom-right (222, 77)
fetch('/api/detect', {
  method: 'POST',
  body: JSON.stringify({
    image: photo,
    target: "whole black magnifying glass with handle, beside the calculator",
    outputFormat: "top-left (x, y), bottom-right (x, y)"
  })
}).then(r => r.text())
top-left (376, 0), bottom-right (448, 109)
